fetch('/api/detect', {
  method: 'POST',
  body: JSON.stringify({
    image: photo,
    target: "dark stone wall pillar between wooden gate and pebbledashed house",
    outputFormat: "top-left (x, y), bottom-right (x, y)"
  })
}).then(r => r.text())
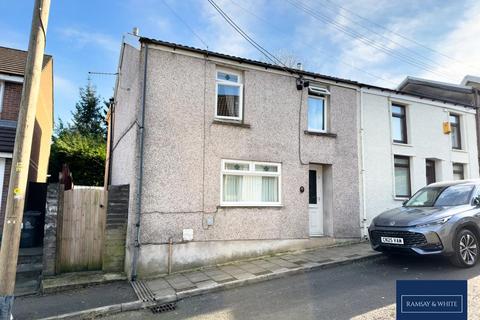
top-left (102, 184), bottom-right (130, 272)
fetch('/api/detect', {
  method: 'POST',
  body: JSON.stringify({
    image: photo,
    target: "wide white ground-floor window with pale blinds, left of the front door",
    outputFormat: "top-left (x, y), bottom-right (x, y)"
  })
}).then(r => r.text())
top-left (221, 160), bottom-right (281, 206)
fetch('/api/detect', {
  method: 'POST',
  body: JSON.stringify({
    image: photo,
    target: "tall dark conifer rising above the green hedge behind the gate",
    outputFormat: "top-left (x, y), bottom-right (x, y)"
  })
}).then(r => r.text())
top-left (72, 80), bottom-right (107, 137)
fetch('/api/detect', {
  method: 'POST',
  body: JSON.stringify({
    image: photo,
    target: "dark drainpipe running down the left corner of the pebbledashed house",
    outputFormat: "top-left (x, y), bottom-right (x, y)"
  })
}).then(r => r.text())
top-left (131, 44), bottom-right (148, 281)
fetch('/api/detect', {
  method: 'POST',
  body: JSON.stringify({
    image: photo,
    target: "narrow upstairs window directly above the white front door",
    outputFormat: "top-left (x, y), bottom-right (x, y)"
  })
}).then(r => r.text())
top-left (307, 86), bottom-right (330, 132)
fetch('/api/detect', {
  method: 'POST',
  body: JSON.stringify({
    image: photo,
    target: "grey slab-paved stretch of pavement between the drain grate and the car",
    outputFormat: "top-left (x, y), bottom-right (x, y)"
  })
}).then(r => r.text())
top-left (137, 242), bottom-right (379, 302)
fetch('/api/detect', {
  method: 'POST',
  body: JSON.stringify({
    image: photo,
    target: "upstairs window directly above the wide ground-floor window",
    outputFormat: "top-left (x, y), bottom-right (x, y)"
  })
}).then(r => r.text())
top-left (215, 70), bottom-right (243, 121)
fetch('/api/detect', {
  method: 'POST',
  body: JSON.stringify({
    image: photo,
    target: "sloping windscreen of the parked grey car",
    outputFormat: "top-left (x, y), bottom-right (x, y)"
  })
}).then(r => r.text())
top-left (405, 185), bottom-right (474, 207)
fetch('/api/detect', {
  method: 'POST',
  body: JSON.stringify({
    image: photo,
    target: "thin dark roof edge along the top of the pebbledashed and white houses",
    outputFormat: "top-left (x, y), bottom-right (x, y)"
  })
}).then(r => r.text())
top-left (139, 37), bottom-right (472, 107)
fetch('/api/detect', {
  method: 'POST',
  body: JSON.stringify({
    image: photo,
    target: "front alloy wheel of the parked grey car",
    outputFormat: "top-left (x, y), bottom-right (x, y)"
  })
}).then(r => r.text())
top-left (450, 229), bottom-right (479, 268)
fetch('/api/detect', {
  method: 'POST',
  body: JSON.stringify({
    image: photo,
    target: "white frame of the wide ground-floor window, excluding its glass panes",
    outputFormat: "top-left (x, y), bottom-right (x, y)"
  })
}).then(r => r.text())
top-left (220, 159), bottom-right (282, 207)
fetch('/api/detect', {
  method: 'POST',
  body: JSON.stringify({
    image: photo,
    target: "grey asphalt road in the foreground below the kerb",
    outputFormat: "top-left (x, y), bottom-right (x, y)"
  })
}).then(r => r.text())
top-left (107, 257), bottom-right (480, 320)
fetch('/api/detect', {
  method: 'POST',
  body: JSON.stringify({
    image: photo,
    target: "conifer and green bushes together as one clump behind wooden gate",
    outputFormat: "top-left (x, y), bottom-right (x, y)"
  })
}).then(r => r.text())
top-left (49, 80), bottom-right (107, 186)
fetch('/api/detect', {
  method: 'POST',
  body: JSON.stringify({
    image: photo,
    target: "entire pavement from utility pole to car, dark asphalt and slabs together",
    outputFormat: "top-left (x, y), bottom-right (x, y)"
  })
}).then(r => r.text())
top-left (9, 242), bottom-right (380, 319)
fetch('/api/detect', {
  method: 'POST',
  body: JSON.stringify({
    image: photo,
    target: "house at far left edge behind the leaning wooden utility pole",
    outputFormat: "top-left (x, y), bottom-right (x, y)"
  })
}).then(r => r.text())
top-left (0, 47), bottom-right (53, 236)
